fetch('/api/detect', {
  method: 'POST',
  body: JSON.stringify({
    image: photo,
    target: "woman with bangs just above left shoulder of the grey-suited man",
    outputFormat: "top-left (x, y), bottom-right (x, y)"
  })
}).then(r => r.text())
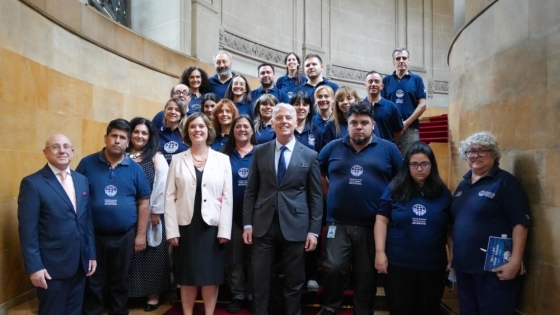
top-left (253, 94), bottom-right (278, 144)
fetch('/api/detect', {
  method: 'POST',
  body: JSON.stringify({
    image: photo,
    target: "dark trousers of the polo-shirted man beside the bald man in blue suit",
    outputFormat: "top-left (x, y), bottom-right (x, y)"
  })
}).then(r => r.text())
top-left (82, 229), bottom-right (136, 315)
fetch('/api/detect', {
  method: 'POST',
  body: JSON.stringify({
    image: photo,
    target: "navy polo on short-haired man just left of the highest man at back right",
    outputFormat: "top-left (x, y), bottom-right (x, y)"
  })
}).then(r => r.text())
top-left (364, 97), bottom-right (403, 142)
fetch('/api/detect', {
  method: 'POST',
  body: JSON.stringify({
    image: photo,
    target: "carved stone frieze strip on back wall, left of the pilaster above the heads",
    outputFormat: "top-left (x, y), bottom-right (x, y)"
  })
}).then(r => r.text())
top-left (220, 29), bottom-right (287, 64)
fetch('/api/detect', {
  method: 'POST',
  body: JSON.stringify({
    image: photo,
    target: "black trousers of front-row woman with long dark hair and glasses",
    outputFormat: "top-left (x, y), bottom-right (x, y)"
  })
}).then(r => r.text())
top-left (385, 264), bottom-right (445, 315)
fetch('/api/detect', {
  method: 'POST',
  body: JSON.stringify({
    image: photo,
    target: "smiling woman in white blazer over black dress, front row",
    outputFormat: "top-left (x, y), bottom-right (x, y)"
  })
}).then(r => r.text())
top-left (165, 113), bottom-right (233, 314)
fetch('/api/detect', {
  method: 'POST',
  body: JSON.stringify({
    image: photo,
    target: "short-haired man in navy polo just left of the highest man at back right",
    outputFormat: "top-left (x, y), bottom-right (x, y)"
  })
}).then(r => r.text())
top-left (364, 70), bottom-right (403, 143)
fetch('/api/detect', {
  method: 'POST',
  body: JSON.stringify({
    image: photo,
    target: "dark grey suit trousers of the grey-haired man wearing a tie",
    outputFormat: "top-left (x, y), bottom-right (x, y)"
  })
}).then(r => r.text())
top-left (252, 216), bottom-right (305, 315)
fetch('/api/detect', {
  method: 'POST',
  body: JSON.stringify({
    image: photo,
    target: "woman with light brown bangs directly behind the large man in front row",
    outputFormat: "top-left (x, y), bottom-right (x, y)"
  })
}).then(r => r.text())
top-left (321, 86), bottom-right (360, 148)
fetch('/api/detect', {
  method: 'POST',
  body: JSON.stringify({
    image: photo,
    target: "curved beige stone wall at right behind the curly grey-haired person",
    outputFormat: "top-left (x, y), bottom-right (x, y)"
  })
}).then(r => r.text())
top-left (449, 0), bottom-right (560, 315)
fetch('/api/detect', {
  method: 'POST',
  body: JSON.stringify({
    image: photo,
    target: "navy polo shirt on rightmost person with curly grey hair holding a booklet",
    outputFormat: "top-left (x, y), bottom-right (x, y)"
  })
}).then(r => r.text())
top-left (451, 165), bottom-right (531, 274)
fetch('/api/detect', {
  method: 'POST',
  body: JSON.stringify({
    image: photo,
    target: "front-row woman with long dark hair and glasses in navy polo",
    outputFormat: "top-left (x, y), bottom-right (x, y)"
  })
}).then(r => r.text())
top-left (373, 141), bottom-right (451, 315)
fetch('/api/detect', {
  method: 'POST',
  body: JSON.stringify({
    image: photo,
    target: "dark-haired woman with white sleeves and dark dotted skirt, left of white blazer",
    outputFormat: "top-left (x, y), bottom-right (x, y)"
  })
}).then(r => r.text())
top-left (126, 117), bottom-right (170, 311)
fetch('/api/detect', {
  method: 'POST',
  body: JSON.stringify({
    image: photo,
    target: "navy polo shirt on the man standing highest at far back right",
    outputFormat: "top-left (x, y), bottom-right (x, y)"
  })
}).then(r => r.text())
top-left (381, 71), bottom-right (426, 129)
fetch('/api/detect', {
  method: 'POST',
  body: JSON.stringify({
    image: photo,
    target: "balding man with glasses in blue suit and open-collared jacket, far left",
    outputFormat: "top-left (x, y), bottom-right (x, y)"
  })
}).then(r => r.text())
top-left (18, 134), bottom-right (97, 315)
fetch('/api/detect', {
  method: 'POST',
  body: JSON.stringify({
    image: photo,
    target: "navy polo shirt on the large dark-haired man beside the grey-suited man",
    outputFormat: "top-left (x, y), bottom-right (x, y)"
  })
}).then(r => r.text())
top-left (318, 136), bottom-right (403, 228)
